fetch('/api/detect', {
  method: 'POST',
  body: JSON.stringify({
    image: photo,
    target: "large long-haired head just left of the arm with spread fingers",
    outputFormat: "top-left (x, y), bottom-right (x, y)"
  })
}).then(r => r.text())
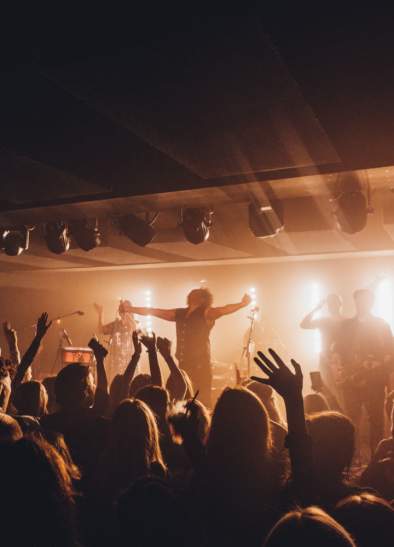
top-left (207, 388), bottom-right (272, 480)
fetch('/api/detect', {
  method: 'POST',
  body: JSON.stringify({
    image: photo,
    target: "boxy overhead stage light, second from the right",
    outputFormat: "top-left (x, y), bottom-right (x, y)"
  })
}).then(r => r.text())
top-left (248, 200), bottom-right (284, 238)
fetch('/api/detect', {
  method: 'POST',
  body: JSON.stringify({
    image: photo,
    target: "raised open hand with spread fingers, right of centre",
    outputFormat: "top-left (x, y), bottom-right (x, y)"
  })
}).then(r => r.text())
top-left (252, 349), bottom-right (303, 399)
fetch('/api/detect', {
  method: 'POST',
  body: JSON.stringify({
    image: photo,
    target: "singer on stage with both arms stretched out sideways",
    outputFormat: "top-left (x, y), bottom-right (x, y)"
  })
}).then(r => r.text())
top-left (123, 288), bottom-right (251, 406)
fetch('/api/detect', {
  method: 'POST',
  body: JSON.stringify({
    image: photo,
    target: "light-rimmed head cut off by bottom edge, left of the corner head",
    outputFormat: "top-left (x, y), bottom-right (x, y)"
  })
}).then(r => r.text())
top-left (264, 507), bottom-right (355, 547)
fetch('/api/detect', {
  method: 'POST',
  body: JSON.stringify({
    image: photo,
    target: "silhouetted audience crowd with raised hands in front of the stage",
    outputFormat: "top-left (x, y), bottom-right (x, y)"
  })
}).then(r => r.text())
top-left (0, 308), bottom-right (394, 547)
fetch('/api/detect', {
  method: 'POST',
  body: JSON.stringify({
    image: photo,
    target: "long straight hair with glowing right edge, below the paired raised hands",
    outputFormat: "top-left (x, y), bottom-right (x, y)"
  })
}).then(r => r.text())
top-left (96, 399), bottom-right (166, 497)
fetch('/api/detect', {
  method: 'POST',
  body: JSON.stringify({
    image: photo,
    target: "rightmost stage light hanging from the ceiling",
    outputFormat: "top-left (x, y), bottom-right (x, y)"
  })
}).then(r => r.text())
top-left (332, 172), bottom-right (373, 234)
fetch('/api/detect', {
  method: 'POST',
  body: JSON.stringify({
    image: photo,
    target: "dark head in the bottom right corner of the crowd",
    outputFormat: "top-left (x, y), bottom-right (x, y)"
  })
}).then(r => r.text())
top-left (335, 493), bottom-right (394, 547)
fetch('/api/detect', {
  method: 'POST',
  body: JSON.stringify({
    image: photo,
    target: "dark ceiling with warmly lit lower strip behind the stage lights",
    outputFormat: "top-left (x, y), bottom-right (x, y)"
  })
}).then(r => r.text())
top-left (0, 11), bottom-right (394, 272)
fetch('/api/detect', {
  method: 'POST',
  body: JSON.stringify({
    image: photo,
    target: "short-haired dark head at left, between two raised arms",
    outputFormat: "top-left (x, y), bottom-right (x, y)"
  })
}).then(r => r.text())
top-left (55, 364), bottom-right (95, 410)
